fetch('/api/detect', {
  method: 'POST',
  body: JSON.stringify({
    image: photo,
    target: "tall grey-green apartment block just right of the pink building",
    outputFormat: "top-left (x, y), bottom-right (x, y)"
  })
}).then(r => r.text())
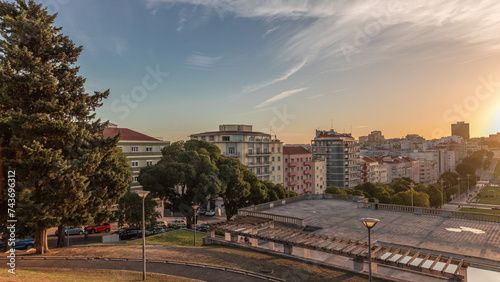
top-left (311, 129), bottom-right (360, 189)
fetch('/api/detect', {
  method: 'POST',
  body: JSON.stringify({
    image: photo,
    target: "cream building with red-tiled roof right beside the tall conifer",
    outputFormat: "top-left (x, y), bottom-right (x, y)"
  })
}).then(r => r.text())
top-left (104, 123), bottom-right (170, 191)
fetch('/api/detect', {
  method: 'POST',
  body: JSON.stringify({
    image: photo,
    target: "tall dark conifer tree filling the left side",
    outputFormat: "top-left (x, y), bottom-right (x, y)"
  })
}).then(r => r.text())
top-left (0, 0), bottom-right (130, 253)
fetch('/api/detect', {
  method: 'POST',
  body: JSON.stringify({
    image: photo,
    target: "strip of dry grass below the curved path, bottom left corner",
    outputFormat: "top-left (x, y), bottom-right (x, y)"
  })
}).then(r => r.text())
top-left (0, 267), bottom-right (198, 282)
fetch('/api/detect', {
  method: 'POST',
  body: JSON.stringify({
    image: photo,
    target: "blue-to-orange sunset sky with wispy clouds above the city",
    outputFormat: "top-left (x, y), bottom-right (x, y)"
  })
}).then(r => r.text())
top-left (37, 0), bottom-right (500, 144)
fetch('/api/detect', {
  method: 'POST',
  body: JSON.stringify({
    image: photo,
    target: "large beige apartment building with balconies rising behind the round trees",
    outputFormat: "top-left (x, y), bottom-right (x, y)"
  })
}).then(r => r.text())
top-left (190, 124), bottom-right (283, 183)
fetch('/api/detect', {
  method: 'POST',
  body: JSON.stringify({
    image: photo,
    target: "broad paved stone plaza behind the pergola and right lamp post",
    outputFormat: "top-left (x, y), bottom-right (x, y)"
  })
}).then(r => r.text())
top-left (263, 199), bottom-right (500, 263)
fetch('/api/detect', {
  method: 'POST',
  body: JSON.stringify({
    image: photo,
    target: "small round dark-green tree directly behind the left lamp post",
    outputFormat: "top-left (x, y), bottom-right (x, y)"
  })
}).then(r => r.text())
top-left (118, 192), bottom-right (160, 229)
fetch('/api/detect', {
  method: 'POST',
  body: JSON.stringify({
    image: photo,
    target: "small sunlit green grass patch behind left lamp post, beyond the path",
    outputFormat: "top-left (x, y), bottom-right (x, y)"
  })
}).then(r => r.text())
top-left (129, 229), bottom-right (206, 246)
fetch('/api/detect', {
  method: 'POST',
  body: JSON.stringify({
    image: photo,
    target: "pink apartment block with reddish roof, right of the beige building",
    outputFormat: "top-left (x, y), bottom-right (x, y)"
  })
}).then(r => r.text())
top-left (283, 146), bottom-right (313, 195)
